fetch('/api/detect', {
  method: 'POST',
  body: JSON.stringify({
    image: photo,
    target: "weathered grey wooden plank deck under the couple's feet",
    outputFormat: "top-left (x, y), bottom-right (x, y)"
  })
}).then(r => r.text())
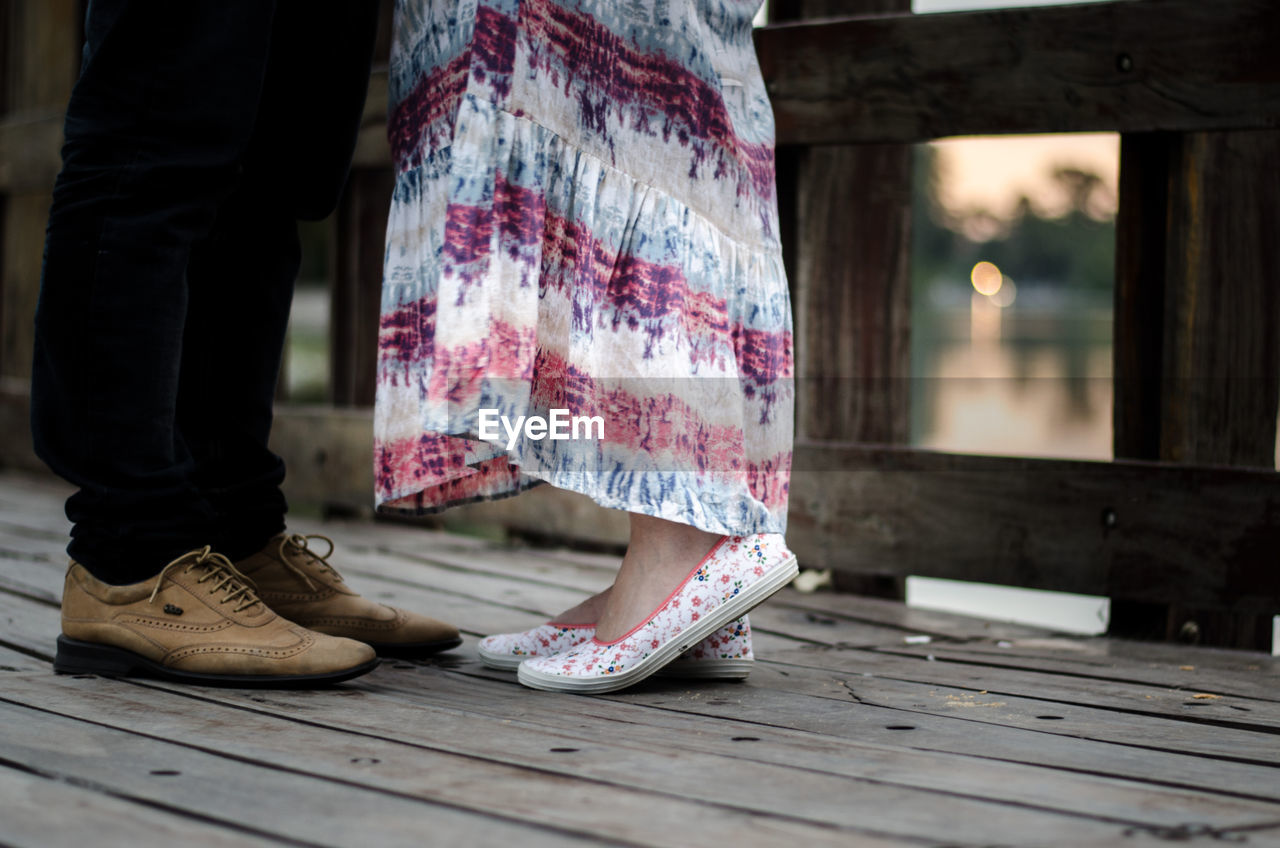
top-left (0, 475), bottom-right (1280, 848)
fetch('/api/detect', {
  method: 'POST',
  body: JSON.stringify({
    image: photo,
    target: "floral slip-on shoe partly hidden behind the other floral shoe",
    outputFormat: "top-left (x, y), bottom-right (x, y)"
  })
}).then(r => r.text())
top-left (479, 615), bottom-right (755, 680)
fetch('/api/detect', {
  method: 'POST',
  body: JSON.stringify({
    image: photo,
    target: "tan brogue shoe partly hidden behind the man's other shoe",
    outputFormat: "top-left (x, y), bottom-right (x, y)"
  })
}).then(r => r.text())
top-left (236, 533), bottom-right (462, 657)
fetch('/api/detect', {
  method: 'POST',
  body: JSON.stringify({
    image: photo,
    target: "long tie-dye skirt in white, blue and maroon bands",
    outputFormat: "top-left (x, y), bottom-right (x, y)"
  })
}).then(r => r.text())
top-left (375, 0), bottom-right (794, 534)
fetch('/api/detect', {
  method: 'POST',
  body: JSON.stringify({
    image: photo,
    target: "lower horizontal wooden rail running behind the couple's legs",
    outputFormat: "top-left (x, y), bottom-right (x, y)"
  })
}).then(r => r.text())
top-left (257, 406), bottom-right (1280, 617)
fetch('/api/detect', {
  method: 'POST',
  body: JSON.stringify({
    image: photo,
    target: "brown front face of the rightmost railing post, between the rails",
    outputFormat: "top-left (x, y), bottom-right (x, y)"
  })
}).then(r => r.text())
top-left (1160, 132), bottom-right (1280, 468)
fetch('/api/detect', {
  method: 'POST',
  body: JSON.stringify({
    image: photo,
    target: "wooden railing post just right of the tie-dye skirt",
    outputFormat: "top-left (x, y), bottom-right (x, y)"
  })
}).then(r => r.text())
top-left (773, 0), bottom-right (911, 597)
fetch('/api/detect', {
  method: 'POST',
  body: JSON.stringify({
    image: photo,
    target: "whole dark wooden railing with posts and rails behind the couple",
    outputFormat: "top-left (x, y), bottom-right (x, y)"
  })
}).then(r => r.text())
top-left (0, 0), bottom-right (1280, 647)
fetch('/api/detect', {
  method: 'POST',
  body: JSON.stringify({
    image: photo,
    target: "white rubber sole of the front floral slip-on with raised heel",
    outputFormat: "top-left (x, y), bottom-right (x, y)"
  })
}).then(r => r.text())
top-left (517, 556), bottom-right (800, 694)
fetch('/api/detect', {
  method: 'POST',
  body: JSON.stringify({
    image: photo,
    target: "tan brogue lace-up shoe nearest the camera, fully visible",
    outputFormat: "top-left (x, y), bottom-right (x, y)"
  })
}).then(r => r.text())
top-left (54, 547), bottom-right (378, 687)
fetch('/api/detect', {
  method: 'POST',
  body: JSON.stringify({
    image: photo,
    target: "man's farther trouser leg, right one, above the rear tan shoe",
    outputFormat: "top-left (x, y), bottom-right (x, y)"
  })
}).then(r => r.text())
top-left (178, 0), bottom-right (379, 560)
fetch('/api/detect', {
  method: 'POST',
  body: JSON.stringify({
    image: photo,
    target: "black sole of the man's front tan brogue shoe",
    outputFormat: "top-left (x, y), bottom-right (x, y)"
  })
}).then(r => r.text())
top-left (54, 635), bottom-right (378, 689)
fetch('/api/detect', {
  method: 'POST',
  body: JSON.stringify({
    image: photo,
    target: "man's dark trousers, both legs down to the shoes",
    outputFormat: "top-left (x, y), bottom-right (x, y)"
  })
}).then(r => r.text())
top-left (32, 0), bottom-right (380, 583)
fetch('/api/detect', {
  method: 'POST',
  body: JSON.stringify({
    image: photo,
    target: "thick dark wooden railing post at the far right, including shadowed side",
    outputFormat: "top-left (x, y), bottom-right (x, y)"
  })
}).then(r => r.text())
top-left (1108, 131), bottom-right (1280, 649)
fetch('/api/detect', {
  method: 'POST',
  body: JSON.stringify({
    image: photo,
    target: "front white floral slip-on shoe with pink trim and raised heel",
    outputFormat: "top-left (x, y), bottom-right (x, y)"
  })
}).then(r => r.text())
top-left (518, 533), bottom-right (799, 693)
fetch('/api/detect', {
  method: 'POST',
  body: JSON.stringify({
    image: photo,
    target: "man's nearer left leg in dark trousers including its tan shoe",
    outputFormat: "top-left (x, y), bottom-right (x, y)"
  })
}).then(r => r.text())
top-left (32, 0), bottom-right (376, 685)
